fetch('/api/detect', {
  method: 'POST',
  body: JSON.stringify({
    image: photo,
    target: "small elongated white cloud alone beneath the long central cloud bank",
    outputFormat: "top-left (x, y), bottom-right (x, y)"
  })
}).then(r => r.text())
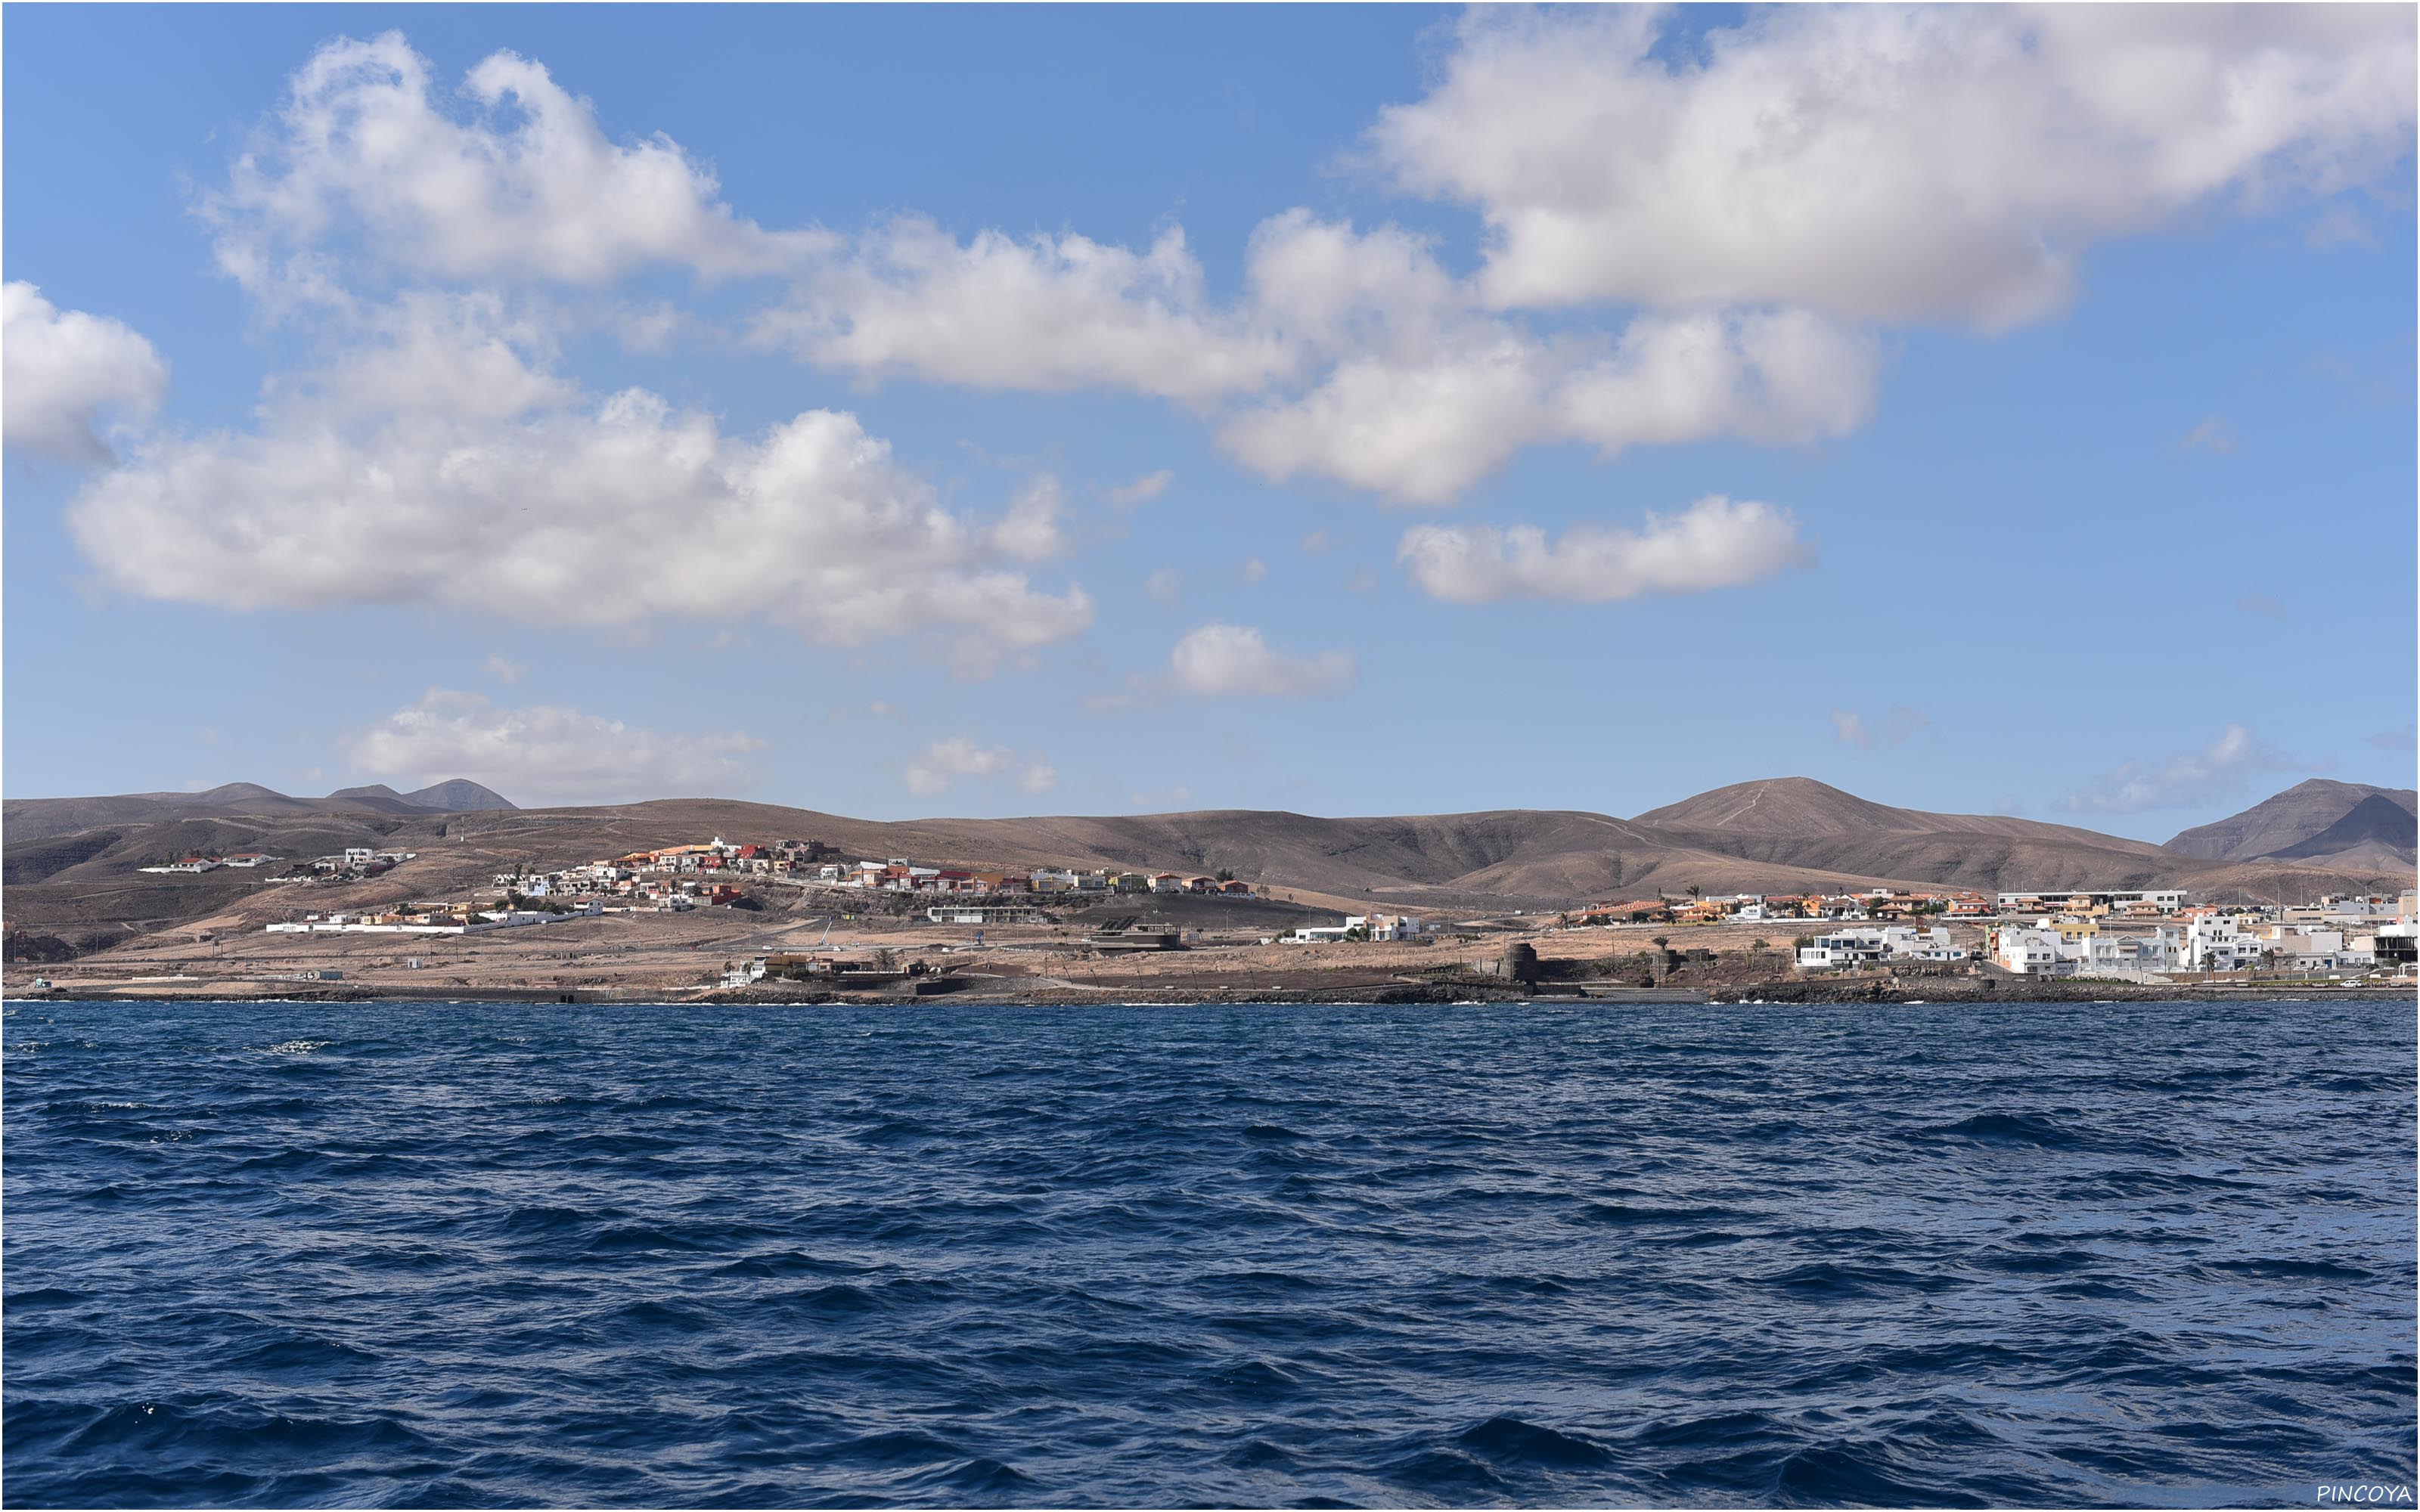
top-left (1396, 494), bottom-right (1813, 605)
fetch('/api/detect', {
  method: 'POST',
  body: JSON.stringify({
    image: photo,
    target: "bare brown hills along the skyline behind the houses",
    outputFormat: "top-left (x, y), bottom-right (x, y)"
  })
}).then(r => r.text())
top-left (5, 776), bottom-right (2412, 948)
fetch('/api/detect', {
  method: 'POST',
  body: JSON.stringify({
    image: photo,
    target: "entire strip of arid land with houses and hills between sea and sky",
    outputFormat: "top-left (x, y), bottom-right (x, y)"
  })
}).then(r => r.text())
top-left (5, 779), bottom-right (2420, 1002)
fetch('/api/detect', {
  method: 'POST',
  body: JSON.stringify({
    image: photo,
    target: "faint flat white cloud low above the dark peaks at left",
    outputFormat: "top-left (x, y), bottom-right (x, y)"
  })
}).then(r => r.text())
top-left (339, 687), bottom-right (765, 808)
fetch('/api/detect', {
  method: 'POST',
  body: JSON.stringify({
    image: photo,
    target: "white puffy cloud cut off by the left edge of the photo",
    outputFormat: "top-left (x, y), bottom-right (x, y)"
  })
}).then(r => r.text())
top-left (0, 280), bottom-right (167, 462)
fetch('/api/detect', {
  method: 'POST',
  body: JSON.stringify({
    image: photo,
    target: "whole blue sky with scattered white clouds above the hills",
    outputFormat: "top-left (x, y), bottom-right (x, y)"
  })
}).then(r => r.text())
top-left (5, 8), bottom-right (2415, 839)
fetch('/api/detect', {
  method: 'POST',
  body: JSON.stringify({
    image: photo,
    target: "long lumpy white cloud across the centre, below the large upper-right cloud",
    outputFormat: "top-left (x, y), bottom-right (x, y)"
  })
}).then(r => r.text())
top-left (758, 210), bottom-right (1878, 503)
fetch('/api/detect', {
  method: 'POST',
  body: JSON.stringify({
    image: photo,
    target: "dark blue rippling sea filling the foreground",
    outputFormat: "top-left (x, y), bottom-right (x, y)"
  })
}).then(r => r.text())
top-left (0, 1002), bottom-right (2420, 1507)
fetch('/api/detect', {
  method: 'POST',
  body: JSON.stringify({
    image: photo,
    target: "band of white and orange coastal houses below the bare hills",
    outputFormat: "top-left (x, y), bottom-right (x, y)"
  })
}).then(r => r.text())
top-left (61, 835), bottom-right (2420, 996)
